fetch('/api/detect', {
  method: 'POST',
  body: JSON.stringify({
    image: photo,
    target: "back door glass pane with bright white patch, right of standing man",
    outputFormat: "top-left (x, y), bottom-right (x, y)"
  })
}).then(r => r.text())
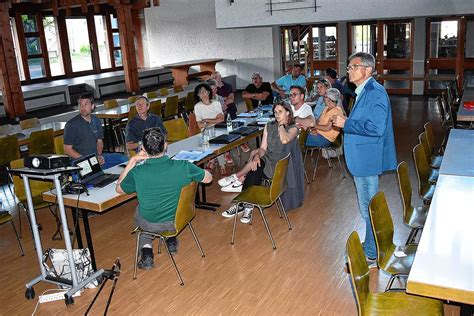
top-left (430, 21), bottom-right (458, 58)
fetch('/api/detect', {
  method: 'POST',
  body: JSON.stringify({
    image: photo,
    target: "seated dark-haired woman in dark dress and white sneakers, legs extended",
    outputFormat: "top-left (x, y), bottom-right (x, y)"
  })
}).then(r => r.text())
top-left (219, 102), bottom-right (298, 223)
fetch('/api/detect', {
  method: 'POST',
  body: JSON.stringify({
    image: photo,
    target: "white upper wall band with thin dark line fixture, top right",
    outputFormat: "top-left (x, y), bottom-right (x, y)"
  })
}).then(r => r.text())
top-left (215, 0), bottom-right (474, 29)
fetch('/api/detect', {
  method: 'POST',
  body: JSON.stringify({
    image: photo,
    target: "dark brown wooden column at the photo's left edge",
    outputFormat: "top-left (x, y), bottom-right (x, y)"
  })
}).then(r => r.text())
top-left (0, 2), bottom-right (26, 119)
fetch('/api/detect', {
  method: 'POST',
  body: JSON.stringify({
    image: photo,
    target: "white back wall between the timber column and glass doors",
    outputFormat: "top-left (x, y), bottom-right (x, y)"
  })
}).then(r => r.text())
top-left (145, 0), bottom-right (278, 89)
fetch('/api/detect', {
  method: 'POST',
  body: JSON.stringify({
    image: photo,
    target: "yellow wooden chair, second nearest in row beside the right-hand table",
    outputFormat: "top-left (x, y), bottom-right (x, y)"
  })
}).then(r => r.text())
top-left (369, 192), bottom-right (417, 291)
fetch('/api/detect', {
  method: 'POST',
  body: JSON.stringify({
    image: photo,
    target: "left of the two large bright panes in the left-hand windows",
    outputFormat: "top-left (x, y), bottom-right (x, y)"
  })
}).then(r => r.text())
top-left (43, 16), bottom-right (64, 76)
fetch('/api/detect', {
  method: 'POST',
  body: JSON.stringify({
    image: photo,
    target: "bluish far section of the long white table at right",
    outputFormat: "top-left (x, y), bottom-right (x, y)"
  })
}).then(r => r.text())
top-left (439, 129), bottom-right (474, 178)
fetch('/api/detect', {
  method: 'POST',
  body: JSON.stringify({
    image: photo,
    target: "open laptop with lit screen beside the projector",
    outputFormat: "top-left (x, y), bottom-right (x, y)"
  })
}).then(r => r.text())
top-left (72, 154), bottom-right (119, 188)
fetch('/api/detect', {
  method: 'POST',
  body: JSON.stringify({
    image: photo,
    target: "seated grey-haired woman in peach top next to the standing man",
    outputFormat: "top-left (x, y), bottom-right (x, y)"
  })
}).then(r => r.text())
top-left (306, 88), bottom-right (344, 147)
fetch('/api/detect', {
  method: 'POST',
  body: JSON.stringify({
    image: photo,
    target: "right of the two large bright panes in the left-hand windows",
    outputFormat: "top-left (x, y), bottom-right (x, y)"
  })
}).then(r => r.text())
top-left (66, 18), bottom-right (92, 72)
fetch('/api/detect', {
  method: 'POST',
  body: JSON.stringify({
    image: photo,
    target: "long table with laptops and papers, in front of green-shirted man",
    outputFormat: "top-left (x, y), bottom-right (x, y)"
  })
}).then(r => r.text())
top-left (43, 123), bottom-right (263, 270)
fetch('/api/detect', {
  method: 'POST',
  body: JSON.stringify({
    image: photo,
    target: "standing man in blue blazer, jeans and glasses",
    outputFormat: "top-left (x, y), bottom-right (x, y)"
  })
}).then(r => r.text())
top-left (333, 52), bottom-right (397, 266)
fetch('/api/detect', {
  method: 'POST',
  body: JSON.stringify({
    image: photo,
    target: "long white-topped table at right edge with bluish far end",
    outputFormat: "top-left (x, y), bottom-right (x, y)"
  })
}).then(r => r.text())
top-left (407, 129), bottom-right (474, 311)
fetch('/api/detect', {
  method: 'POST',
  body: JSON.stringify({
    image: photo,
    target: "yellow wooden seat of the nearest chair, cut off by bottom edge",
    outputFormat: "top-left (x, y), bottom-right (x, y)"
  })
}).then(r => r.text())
top-left (362, 292), bottom-right (444, 316)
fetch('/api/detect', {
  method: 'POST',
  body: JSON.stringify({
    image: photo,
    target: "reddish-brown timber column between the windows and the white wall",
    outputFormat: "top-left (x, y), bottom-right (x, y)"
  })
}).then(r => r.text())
top-left (116, 3), bottom-right (140, 93)
